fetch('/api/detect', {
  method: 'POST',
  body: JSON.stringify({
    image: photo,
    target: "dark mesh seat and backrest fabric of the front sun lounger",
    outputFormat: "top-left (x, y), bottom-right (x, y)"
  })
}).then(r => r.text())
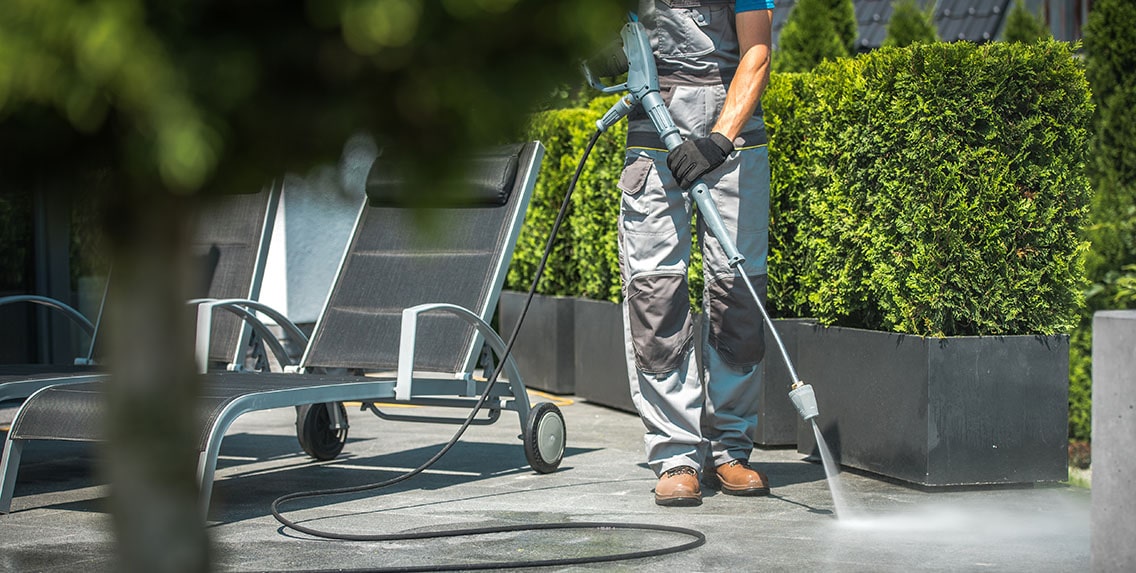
top-left (10, 142), bottom-right (541, 448)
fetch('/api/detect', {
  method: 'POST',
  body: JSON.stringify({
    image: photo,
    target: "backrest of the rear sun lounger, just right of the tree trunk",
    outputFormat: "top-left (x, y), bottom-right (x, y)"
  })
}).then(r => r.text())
top-left (192, 184), bottom-right (281, 364)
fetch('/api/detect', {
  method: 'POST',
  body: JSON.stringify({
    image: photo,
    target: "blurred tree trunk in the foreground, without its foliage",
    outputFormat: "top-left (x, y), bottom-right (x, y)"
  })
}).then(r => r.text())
top-left (103, 192), bottom-right (209, 573)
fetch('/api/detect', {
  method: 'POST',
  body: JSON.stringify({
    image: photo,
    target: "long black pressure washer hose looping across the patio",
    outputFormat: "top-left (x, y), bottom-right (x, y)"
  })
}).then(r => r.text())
top-left (272, 130), bottom-right (707, 572)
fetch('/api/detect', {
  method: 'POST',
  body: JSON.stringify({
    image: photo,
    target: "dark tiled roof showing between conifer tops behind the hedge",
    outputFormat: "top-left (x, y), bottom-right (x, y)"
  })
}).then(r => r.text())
top-left (772, 0), bottom-right (1011, 51)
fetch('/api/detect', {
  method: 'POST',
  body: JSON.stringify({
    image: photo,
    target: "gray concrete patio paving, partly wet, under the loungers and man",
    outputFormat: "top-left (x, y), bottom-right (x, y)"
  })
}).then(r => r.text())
top-left (0, 399), bottom-right (1091, 572)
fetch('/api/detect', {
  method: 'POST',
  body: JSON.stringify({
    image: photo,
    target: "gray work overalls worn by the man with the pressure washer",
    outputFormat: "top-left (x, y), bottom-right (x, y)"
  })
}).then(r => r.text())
top-left (619, 0), bottom-right (769, 474)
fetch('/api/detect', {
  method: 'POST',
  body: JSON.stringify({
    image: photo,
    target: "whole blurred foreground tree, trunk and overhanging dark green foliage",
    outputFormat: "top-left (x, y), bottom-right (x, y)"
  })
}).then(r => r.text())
top-left (0, 0), bottom-right (634, 572)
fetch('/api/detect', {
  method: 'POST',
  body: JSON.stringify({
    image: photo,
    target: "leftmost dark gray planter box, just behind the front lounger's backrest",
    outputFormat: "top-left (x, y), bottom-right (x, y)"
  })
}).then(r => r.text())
top-left (498, 291), bottom-right (576, 395)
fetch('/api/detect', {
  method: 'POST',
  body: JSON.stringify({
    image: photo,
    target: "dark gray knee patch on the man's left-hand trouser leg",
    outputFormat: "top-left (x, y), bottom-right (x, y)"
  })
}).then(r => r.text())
top-left (626, 274), bottom-right (694, 374)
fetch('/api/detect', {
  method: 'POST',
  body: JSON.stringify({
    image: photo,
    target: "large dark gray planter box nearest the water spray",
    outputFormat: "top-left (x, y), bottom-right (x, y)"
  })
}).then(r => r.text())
top-left (797, 326), bottom-right (1069, 485)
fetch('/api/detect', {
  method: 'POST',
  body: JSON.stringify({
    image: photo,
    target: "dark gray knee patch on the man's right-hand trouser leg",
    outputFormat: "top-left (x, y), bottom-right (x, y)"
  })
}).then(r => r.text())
top-left (707, 274), bottom-right (767, 367)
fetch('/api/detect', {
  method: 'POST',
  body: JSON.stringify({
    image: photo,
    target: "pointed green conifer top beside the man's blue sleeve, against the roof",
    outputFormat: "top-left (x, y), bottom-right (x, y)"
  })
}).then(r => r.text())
top-left (772, 0), bottom-right (855, 72)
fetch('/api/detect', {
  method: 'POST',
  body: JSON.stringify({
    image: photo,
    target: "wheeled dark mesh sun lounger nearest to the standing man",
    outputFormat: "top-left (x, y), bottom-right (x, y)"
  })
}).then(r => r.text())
top-left (0, 142), bottom-right (565, 513)
